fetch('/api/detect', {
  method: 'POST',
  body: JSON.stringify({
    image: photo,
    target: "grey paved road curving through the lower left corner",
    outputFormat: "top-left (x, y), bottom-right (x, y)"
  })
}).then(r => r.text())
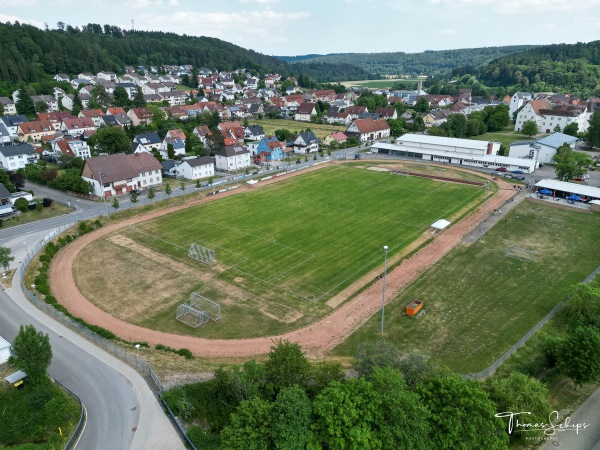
top-left (0, 229), bottom-right (184, 450)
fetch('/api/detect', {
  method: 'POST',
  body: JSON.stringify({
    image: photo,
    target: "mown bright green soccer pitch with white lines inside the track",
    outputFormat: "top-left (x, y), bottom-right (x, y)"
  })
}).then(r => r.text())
top-left (127, 164), bottom-right (481, 300)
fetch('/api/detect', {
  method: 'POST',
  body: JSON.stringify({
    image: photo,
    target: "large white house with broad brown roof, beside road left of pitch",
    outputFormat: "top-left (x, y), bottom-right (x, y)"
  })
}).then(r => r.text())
top-left (81, 152), bottom-right (162, 197)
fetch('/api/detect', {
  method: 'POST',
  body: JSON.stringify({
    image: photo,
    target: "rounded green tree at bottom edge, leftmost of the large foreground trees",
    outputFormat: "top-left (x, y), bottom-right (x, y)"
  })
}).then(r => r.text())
top-left (221, 398), bottom-right (272, 450)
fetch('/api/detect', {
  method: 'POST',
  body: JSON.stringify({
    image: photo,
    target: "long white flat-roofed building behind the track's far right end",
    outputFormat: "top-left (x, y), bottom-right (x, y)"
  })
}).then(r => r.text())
top-left (371, 134), bottom-right (537, 173)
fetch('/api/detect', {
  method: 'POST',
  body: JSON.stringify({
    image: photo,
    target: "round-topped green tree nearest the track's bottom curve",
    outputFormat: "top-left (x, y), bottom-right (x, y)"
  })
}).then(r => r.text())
top-left (265, 340), bottom-right (310, 392)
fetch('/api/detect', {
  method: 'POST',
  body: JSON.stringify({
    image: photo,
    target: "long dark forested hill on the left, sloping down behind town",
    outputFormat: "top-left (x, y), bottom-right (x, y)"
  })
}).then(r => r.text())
top-left (0, 22), bottom-right (370, 89)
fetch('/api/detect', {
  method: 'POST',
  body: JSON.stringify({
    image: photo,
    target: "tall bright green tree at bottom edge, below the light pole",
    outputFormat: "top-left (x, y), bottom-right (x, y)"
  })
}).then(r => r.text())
top-left (370, 367), bottom-right (434, 450)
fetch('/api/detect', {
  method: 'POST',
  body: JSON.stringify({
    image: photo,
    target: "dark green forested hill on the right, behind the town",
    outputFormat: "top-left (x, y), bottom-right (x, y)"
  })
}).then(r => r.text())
top-left (474, 41), bottom-right (600, 96)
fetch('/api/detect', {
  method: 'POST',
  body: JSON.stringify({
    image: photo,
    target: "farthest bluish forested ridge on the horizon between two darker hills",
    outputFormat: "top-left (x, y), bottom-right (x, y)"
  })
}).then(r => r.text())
top-left (277, 45), bottom-right (536, 75)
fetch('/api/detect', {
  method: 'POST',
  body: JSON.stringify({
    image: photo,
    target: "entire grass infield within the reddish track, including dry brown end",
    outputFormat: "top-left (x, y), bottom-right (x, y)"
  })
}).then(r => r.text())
top-left (74, 165), bottom-right (483, 338)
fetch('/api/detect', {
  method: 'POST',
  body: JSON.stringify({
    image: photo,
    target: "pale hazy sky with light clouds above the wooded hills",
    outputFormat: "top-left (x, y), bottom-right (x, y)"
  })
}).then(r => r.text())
top-left (0, 0), bottom-right (600, 56)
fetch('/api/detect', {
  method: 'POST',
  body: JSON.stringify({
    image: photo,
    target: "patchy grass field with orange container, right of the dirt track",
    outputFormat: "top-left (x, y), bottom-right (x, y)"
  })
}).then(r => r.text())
top-left (334, 201), bottom-right (600, 373)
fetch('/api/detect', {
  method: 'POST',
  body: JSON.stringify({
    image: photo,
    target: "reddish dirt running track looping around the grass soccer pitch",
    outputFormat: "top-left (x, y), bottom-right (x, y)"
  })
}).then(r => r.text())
top-left (50, 166), bottom-right (516, 359)
